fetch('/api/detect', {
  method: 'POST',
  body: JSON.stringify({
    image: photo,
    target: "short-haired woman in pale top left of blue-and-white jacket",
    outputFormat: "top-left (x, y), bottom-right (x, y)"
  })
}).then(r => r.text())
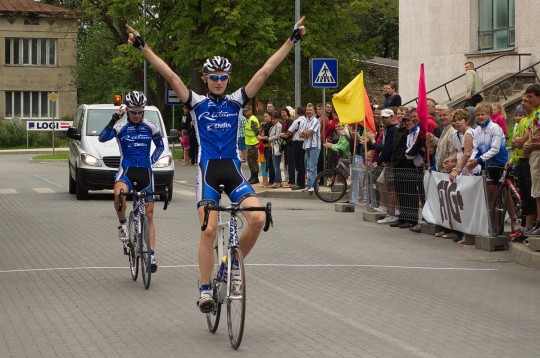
top-left (444, 109), bottom-right (480, 182)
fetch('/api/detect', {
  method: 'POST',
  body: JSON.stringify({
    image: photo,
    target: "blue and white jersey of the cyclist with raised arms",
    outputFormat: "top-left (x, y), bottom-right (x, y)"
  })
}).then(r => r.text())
top-left (186, 88), bottom-right (249, 163)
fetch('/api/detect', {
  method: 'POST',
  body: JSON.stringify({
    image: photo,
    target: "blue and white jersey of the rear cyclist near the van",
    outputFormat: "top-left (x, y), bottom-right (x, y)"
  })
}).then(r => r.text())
top-left (99, 119), bottom-right (164, 168)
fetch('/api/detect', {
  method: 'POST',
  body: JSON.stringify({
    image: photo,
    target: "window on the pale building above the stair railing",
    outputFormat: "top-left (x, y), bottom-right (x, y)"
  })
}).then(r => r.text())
top-left (478, 0), bottom-right (516, 51)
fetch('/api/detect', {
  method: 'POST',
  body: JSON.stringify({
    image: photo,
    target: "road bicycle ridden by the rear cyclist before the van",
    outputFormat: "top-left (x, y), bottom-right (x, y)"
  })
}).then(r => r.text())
top-left (118, 182), bottom-right (169, 289)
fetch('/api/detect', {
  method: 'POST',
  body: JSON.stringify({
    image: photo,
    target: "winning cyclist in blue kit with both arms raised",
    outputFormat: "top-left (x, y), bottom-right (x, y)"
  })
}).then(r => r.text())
top-left (126, 17), bottom-right (306, 313)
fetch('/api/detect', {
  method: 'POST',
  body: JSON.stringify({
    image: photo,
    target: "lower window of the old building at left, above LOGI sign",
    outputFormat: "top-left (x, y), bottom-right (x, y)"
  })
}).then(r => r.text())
top-left (5, 91), bottom-right (58, 119)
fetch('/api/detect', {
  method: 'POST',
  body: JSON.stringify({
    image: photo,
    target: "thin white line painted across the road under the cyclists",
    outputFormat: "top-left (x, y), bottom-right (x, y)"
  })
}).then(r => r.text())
top-left (0, 264), bottom-right (498, 273)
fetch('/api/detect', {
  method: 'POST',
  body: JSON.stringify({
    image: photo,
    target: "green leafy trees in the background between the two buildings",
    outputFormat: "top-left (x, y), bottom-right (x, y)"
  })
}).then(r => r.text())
top-left (74, 0), bottom-right (398, 126)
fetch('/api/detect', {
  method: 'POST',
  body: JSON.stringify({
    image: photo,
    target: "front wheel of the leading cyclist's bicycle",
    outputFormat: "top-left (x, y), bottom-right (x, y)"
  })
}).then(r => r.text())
top-left (227, 247), bottom-right (246, 349)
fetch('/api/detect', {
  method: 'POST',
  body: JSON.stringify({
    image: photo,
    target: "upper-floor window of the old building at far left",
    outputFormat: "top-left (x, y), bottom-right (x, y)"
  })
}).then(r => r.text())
top-left (4, 38), bottom-right (58, 66)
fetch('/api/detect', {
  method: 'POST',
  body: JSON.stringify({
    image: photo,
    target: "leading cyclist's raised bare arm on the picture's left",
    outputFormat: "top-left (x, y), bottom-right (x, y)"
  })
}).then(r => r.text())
top-left (126, 24), bottom-right (189, 103)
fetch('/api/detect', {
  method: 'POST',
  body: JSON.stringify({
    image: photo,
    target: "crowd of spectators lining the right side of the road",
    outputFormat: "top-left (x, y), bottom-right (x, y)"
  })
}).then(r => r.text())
top-left (182, 67), bottom-right (540, 242)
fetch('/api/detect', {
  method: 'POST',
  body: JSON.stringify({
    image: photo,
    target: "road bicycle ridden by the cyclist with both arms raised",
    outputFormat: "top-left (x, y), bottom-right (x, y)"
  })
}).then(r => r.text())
top-left (201, 185), bottom-right (273, 349)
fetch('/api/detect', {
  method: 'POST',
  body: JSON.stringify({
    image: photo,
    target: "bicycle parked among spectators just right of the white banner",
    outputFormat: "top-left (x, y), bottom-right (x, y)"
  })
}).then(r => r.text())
top-left (491, 167), bottom-right (521, 236)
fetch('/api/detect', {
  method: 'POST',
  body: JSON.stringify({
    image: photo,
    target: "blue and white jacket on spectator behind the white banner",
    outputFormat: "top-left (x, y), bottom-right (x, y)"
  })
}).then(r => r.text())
top-left (471, 119), bottom-right (508, 168)
